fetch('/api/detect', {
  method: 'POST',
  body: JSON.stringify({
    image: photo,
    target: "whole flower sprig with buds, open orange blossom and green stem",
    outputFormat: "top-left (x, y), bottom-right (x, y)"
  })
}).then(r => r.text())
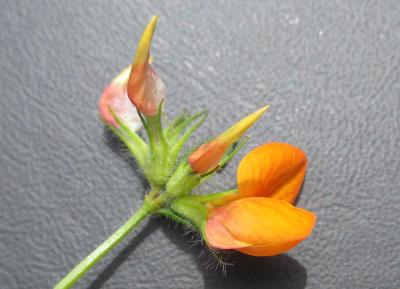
top-left (56, 16), bottom-right (316, 288)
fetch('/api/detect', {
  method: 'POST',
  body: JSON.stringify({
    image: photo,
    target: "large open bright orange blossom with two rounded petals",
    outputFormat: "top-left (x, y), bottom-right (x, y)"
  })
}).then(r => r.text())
top-left (204, 143), bottom-right (316, 256)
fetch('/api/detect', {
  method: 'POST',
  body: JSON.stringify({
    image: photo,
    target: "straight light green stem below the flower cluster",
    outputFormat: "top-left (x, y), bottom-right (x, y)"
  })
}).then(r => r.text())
top-left (54, 202), bottom-right (157, 289)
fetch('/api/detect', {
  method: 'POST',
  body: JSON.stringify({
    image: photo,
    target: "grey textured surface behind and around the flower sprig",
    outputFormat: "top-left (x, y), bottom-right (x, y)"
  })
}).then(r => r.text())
top-left (0, 0), bottom-right (400, 289)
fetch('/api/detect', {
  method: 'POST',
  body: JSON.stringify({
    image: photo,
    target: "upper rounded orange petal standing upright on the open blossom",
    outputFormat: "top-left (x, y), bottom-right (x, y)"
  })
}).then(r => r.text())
top-left (236, 143), bottom-right (307, 203)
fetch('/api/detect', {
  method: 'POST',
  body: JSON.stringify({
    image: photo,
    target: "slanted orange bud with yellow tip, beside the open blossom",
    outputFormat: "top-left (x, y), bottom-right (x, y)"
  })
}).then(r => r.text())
top-left (188, 106), bottom-right (268, 174)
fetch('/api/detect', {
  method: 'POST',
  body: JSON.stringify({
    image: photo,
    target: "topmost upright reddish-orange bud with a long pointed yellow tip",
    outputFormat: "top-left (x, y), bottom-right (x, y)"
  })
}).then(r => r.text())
top-left (128, 16), bottom-right (165, 116)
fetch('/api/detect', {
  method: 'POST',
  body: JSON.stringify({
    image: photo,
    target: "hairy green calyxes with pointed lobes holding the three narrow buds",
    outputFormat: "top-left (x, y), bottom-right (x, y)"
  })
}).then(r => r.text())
top-left (108, 103), bottom-right (248, 199)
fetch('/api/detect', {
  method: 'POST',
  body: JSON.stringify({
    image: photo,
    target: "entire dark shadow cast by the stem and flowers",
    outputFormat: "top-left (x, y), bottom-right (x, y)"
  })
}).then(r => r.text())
top-left (99, 129), bottom-right (307, 289)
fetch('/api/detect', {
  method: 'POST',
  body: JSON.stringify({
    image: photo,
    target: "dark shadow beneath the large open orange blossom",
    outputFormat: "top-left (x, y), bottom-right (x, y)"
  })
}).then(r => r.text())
top-left (162, 219), bottom-right (307, 289)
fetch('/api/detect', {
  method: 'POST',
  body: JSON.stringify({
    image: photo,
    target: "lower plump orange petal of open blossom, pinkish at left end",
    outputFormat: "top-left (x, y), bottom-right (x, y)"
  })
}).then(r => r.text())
top-left (205, 197), bottom-right (316, 256)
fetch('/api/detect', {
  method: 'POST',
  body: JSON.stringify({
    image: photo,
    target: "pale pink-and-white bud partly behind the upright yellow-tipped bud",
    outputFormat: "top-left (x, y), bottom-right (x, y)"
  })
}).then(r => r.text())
top-left (99, 66), bottom-right (142, 131)
